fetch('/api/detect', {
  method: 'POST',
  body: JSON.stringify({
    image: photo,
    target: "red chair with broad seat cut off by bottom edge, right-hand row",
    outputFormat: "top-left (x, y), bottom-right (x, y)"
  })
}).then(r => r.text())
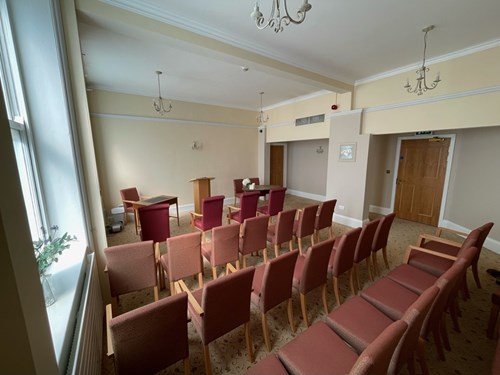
top-left (278, 320), bottom-right (407, 375)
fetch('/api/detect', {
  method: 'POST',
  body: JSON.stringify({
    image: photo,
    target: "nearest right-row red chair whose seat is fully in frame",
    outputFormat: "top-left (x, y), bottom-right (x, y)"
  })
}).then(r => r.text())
top-left (326, 286), bottom-right (439, 375)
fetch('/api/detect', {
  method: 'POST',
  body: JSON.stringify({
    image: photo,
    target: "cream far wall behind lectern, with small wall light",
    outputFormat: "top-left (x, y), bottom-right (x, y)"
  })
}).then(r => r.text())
top-left (90, 92), bottom-right (258, 212)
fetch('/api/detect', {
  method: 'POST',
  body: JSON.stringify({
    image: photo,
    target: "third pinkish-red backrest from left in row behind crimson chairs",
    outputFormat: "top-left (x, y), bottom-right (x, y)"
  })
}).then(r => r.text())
top-left (209, 224), bottom-right (240, 266)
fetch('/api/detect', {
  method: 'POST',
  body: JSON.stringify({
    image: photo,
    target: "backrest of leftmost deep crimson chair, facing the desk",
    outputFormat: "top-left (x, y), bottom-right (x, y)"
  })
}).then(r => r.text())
top-left (139, 203), bottom-right (170, 242)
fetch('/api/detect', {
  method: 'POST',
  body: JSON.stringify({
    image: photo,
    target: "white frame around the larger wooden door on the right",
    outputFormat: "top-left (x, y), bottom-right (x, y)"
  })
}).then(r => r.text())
top-left (391, 134), bottom-right (456, 227)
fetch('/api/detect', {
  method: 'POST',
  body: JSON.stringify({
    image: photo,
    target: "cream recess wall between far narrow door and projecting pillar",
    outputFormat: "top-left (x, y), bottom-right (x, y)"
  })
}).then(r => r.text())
top-left (287, 139), bottom-right (328, 196)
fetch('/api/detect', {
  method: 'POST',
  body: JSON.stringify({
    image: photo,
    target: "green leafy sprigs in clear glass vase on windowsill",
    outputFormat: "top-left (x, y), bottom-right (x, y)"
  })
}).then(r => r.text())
top-left (33, 225), bottom-right (76, 306)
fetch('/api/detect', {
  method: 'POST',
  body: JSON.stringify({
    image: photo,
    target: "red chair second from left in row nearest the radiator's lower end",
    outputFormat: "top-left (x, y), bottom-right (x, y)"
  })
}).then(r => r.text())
top-left (179, 267), bottom-right (255, 375)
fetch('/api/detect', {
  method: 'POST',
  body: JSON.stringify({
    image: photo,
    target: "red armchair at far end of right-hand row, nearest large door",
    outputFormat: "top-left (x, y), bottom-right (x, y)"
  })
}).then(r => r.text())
top-left (417, 222), bottom-right (494, 288)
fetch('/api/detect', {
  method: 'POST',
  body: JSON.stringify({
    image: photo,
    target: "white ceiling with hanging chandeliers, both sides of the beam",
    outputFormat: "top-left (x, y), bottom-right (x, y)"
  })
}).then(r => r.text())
top-left (78, 0), bottom-right (500, 110)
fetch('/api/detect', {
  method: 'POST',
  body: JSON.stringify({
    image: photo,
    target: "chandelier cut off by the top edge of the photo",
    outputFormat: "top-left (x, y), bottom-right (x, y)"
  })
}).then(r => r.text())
top-left (250, 0), bottom-right (311, 33)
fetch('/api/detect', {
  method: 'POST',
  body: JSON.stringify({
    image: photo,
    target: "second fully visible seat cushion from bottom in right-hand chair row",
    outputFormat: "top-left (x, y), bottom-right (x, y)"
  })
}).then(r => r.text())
top-left (361, 277), bottom-right (418, 320)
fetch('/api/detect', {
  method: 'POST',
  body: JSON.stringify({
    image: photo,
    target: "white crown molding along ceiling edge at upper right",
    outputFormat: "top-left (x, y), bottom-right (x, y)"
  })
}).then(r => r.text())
top-left (354, 39), bottom-right (500, 86)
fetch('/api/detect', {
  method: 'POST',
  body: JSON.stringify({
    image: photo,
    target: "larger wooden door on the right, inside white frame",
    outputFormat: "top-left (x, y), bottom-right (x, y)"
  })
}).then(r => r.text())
top-left (394, 138), bottom-right (450, 226)
